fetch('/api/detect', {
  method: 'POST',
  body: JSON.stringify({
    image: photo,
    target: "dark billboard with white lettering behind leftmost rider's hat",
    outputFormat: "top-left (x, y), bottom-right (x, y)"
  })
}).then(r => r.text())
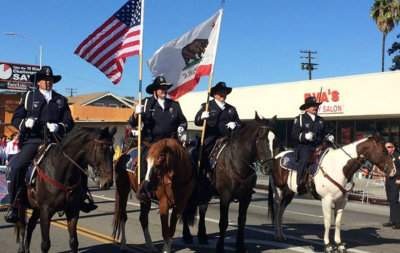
top-left (0, 62), bottom-right (40, 91)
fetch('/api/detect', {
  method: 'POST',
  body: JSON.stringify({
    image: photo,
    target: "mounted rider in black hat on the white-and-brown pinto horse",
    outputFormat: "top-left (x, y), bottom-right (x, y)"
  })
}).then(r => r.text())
top-left (291, 96), bottom-right (334, 193)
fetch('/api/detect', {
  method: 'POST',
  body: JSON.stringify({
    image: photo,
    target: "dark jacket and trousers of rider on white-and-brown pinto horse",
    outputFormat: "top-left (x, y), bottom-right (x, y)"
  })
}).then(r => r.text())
top-left (291, 98), bottom-right (327, 185)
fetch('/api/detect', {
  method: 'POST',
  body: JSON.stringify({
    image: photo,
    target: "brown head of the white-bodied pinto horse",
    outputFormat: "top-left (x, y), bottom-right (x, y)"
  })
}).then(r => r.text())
top-left (357, 136), bottom-right (396, 176)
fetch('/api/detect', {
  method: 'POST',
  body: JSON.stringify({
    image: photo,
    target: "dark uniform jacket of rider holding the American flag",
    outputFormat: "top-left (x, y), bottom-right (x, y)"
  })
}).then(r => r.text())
top-left (129, 97), bottom-right (187, 142)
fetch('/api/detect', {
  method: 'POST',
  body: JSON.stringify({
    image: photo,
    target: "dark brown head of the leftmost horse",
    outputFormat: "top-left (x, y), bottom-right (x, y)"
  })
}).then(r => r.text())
top-left (87, 127), bottom-right (116, 189)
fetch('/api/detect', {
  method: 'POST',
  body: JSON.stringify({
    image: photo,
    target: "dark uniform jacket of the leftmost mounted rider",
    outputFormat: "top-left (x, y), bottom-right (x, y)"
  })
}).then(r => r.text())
top-left (11, 90), bottom-right (74, 142)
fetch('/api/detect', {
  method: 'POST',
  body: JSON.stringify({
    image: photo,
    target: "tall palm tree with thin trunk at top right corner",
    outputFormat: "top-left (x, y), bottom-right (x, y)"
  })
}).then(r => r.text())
top-left (371, 0), bottom-right (400, 72)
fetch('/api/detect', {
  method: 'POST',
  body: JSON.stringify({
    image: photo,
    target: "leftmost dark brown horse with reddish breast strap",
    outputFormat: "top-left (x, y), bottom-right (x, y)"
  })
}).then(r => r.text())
top-left (15, 127), bottom-right (116, 253)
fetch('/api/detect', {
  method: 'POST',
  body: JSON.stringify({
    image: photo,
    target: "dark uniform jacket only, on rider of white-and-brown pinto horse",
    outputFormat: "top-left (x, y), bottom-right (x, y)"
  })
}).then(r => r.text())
top-left (291, 113), bottom-right (326, 148)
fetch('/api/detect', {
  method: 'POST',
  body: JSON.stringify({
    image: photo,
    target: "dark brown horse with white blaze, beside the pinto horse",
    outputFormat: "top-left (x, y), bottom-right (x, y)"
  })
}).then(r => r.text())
top-left (182, 113), bottom-right (278, 253)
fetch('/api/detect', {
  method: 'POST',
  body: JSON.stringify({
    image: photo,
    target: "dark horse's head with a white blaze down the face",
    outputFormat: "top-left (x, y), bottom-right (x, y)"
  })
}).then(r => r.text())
top-left (255, 112), bottom-right (277, 174)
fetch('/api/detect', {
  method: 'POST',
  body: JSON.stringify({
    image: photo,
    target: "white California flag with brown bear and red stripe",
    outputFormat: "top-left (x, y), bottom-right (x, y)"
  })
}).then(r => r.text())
top-left (147, 9), bottom-right (222, 99)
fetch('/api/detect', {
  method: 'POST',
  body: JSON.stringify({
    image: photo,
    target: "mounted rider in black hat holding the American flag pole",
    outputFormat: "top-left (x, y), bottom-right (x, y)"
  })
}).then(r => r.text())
top-left (128, 76), bottom-right (187, 197)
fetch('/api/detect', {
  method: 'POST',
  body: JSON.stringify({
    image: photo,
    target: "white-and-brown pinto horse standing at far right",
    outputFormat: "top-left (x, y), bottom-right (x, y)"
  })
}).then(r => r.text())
top-left (268, 136), bottom-right (395, 252)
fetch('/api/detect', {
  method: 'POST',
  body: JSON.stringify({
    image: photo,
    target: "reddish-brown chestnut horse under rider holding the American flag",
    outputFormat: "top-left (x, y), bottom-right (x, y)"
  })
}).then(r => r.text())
top-left (112, 138), bottom-right (196, 253)
